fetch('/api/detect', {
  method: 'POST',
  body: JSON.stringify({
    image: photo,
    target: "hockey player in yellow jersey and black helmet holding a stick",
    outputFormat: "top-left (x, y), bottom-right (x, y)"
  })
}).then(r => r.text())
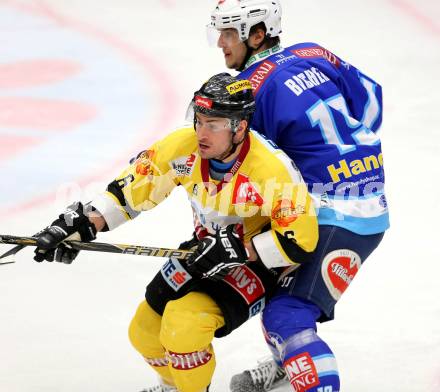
top-left (35, 73), bottom-right (318, 392)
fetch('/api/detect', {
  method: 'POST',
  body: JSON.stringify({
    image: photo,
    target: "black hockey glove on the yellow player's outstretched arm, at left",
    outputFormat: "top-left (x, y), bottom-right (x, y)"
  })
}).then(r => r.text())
top-left (34, 202), bottom-right (96, 264)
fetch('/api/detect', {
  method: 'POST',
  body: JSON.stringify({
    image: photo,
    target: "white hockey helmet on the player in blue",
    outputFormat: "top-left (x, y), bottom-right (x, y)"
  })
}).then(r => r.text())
top-left (210, 0), bottom-right (282, 41)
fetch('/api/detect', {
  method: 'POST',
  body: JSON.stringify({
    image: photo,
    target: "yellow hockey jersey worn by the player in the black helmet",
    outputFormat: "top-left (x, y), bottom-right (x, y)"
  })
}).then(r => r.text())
top-left (92, 127), bottom-right (318, 268)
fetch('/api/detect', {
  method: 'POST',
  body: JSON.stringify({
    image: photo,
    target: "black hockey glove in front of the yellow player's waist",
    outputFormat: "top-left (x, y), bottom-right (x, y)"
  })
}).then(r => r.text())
top-left (186, 225), bottom-right (248, 280)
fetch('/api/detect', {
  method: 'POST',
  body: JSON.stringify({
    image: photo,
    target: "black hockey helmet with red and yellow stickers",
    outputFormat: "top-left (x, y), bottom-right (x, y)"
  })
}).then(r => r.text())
top-left (191, 72), bottom-right (255, 127)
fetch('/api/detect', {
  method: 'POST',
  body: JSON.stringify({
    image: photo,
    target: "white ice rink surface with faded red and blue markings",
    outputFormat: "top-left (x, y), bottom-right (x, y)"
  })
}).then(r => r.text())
top-left (0, 0), bottom-right (440, 392)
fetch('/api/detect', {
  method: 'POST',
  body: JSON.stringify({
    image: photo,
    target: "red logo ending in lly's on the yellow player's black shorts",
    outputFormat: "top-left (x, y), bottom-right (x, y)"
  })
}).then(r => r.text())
top-left (224, 266), bottom-right (265, 305)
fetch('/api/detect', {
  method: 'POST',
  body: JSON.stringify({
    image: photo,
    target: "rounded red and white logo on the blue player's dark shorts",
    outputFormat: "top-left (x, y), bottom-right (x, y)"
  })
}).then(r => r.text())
top-left (321, 249), bottom-right (362, 301)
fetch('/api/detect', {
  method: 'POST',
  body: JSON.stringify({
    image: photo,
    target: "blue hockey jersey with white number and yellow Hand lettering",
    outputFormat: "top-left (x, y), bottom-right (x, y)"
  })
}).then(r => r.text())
top-left (239, 43), bottom-right (389, 235)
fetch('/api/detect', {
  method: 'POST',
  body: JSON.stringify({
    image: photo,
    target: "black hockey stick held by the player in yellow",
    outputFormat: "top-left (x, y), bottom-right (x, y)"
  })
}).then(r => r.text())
top-left (0, 234), bottom-right (193, 265)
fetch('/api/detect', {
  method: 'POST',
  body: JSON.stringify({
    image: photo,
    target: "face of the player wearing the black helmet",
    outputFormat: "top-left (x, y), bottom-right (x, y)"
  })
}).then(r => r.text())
top-left (195, 113), bottom-right (233, 159)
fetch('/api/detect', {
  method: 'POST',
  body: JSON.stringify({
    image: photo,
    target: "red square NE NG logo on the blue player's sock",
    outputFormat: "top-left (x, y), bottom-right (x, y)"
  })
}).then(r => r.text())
top-left (283, 353), bottom-right (319, 392)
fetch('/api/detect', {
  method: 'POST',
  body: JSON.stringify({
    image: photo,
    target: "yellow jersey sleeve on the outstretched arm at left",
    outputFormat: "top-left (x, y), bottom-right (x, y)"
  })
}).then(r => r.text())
top-left (91, 128), bottom-right (194, 230)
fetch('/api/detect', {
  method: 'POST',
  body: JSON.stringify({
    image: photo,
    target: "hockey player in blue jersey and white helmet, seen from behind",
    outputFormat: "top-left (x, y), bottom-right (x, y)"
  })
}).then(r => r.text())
top-left (208, 0), bottom-right (389, 392)
